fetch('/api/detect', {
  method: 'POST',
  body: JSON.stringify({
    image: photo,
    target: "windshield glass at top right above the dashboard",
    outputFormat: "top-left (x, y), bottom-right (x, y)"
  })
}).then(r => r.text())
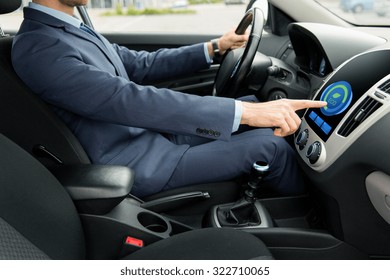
top-left (314, 0), bottom-right (390, 26)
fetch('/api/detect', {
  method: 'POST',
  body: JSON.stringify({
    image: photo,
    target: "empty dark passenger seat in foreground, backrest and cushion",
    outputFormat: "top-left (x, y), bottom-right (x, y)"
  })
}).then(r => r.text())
top-left (0, 134), bottom-right (272, 259)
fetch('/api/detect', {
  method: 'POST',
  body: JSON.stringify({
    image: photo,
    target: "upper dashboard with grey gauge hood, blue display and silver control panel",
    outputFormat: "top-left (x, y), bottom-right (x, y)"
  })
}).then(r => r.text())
top-left (289, 23), bottom-right (390, 172)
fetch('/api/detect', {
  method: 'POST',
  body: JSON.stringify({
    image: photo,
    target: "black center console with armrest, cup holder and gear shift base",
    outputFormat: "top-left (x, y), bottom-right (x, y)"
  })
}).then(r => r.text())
top-left (52, 158), bottom-right (368, 259)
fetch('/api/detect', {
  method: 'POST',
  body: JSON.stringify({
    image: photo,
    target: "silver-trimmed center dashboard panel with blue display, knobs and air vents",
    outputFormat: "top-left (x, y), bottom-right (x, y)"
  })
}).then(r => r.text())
top-left (295, 50), bottom-right (390, 172)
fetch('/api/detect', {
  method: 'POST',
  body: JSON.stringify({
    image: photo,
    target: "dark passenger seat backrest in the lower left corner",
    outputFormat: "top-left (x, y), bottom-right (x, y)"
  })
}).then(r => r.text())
top-left (0, 134), bottom-right (85, 259)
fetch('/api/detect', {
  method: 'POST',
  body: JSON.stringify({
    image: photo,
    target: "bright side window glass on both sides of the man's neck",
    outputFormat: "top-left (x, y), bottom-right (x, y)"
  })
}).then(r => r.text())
top-left (2, 0), bottom-right (248, 34)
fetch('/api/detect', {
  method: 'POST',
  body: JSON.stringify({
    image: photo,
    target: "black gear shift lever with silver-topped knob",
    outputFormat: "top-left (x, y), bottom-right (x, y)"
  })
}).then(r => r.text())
top-left (245, 161), bottom-right (270, 202)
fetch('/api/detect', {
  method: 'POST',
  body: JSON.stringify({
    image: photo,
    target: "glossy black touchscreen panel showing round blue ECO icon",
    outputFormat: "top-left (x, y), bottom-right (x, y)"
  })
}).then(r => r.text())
top-left (305, 50), bottom-right (390, 142)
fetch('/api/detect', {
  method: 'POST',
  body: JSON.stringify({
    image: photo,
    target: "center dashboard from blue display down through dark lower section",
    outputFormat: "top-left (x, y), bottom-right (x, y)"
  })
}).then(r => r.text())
top-left (294, 49), bottom-right (390, 255)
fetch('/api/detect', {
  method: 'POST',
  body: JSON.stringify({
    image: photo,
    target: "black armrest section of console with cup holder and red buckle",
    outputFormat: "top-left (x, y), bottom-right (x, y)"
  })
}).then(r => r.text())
top-left (51, 164), bottom-right (194, 259)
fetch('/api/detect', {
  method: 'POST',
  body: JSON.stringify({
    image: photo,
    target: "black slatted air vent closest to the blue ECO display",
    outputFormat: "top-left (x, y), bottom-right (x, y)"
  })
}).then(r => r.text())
top-left (338, 96), bottom-right (382, 137)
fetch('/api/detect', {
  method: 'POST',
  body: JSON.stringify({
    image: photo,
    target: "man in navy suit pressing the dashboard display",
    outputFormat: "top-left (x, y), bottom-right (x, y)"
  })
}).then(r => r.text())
top-left (12, 0), bottom-right (325, 197)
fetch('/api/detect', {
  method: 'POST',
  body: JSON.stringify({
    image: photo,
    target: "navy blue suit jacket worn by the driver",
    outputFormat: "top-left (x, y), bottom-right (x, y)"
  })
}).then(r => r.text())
top-left (12, 8), bottom-right (235, 196)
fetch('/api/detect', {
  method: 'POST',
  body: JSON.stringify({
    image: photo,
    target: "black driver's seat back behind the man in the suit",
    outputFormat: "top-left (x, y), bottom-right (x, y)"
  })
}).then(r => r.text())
top-left (0, 36), bottom-right (90, 166)
